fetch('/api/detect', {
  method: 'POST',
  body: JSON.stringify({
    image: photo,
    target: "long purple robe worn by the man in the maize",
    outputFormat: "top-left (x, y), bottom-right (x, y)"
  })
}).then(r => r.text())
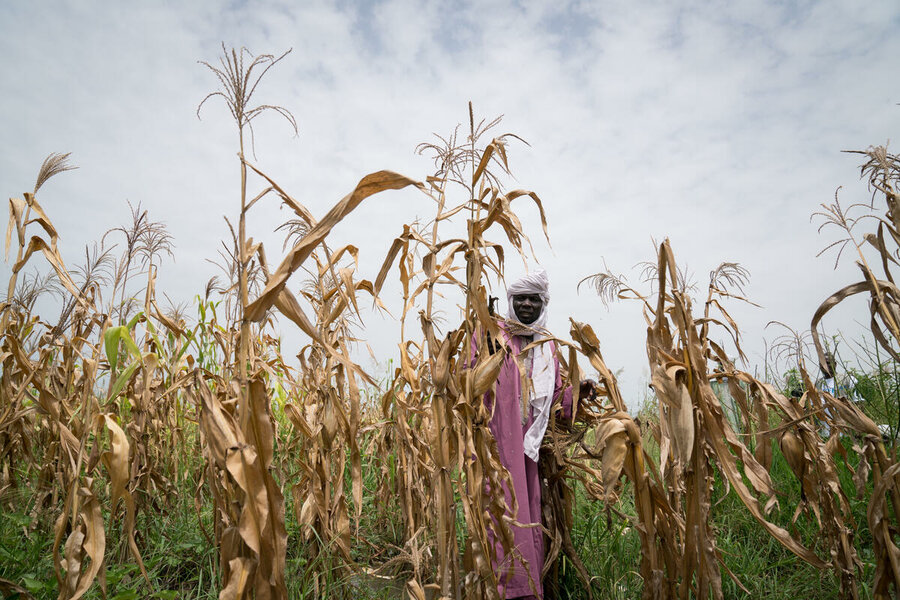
top-left (486, 332), bottom-right (572, 598)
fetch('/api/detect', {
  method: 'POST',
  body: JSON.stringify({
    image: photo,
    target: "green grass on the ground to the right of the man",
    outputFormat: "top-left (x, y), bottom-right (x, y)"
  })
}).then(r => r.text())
top-left (544, 440), bottom-right (875, 600)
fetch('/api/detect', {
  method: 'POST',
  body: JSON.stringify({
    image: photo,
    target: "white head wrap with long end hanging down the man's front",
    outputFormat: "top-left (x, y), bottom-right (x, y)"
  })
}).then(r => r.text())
top-left (506, 269), bottom-right (556, 462)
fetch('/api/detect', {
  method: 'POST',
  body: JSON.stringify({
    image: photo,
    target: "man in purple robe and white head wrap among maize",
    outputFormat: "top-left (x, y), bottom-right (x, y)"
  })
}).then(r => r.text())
top-left (488, 269), bottom-right (594, 599)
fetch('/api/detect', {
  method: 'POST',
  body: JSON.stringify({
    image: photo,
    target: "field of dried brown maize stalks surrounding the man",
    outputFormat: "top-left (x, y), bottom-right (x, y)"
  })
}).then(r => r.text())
top-left (0, 48), bottom-right (900, 600)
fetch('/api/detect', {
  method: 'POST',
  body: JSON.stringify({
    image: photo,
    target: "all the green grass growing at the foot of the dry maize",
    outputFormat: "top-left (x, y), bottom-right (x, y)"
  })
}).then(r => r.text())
top-left (0, 432), bottom-right (874, 600)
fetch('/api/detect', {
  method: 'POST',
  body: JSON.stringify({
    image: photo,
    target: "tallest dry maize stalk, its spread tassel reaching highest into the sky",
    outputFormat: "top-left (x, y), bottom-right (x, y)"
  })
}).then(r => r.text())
top-left (195, 45), bottom-right (297, 599)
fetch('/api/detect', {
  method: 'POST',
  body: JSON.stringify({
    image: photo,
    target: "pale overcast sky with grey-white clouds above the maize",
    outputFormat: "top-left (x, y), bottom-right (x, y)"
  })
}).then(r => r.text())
top-left (0, 0), bottom-right (900, 405)
